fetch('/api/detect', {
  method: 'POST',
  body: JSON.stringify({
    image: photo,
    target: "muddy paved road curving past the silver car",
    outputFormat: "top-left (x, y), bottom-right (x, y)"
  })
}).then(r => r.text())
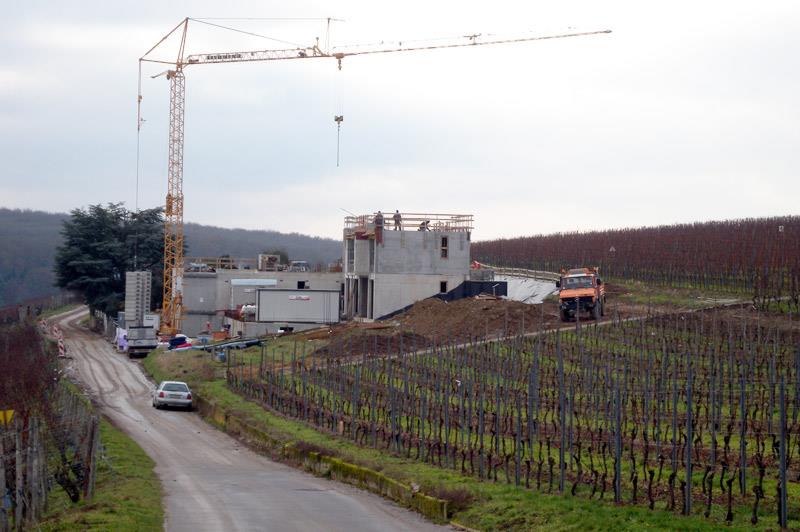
top-left (57, 309), bottom-right (443, 531)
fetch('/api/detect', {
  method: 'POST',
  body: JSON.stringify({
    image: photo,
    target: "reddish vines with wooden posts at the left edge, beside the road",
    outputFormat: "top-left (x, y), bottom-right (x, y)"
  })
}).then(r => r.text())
top-left (0, 322), bottom-right (100, 532)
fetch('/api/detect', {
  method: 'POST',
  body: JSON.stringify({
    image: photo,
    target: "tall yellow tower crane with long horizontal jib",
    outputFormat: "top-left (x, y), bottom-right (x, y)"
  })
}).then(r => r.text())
top-left (137, 17), bottom-right (611, 336)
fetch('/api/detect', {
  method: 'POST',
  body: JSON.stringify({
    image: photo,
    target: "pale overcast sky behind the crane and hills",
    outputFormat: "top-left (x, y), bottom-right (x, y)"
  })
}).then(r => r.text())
top-left (0, 0), bottom-right (800, 239)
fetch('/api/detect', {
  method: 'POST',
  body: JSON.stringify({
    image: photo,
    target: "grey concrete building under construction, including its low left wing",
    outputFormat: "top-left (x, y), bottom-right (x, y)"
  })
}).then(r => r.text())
top-left (175, 212), bottom-right (506, 336)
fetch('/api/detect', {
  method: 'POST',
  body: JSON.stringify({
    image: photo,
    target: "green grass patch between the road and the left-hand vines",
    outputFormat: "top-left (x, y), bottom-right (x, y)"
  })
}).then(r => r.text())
top-left (40, 419), bottom-right (164, 531)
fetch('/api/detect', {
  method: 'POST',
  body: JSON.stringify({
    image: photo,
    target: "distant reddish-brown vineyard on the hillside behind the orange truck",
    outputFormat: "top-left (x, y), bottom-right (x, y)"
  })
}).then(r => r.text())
top-left (472, 216), bottom-right (800, 312)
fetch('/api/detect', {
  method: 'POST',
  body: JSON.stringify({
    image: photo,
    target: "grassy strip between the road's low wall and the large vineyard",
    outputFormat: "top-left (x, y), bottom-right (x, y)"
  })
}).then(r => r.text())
top-left (144, 352), bottom-right (772, 530)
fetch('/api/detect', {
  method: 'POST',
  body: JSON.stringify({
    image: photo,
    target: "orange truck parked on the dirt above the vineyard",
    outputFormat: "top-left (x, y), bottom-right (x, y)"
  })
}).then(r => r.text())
top-left (556, 268), bottom-right (606, 321)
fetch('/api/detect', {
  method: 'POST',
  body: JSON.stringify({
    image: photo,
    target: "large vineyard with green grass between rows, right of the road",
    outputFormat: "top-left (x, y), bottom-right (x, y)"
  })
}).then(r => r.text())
top-left (227, 310), bottom-right (800, 527)
